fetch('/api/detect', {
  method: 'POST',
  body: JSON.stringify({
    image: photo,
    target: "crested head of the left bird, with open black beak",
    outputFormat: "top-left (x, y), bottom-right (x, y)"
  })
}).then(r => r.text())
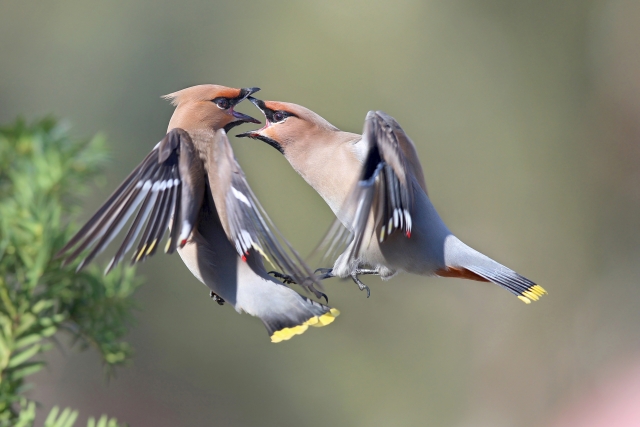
top-left (163, 85), bottom-right (260, 132)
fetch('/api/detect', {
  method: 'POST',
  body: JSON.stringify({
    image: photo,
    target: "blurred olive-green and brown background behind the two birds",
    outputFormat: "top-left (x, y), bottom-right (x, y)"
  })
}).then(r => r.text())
top-left (0, 0), bottom-right (640, 427)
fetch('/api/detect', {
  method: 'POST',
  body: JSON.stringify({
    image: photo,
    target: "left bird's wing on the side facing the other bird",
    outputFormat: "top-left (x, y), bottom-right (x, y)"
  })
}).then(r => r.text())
top-left (206, 129), bottom-right (321, 296)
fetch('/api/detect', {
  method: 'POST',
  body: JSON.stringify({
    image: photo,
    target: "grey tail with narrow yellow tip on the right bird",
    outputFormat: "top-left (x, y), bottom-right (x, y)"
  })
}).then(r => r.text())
top-left (438, 235), bottom-right (547, 304)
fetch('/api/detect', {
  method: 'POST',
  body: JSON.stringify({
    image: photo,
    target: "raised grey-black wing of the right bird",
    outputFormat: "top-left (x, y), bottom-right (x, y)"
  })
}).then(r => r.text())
top-left (323, 111), bottom-right (426, 263)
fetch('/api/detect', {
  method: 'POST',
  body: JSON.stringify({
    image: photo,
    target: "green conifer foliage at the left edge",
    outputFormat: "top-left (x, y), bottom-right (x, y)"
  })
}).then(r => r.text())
top-left (0, 118), bottom-right (140, 427)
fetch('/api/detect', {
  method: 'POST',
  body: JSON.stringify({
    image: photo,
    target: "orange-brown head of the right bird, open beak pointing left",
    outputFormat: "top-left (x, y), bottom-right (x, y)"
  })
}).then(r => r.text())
top-left (236, 96), bottom-right (339, 157)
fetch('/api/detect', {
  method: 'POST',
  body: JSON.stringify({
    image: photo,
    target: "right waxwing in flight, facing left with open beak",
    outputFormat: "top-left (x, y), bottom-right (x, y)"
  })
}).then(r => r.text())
top-left (237, 96), bottom-right (547, 304)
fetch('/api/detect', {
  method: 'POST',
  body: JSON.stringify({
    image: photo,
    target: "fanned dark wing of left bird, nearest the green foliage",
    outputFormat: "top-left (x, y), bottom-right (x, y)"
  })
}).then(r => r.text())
top-left (57, 128), bottom-right (204, 274)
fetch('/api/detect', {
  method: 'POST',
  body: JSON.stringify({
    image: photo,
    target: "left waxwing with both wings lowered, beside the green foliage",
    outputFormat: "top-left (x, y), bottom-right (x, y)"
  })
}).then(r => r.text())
top-left (58, 84), bottom-right (340, 342)
